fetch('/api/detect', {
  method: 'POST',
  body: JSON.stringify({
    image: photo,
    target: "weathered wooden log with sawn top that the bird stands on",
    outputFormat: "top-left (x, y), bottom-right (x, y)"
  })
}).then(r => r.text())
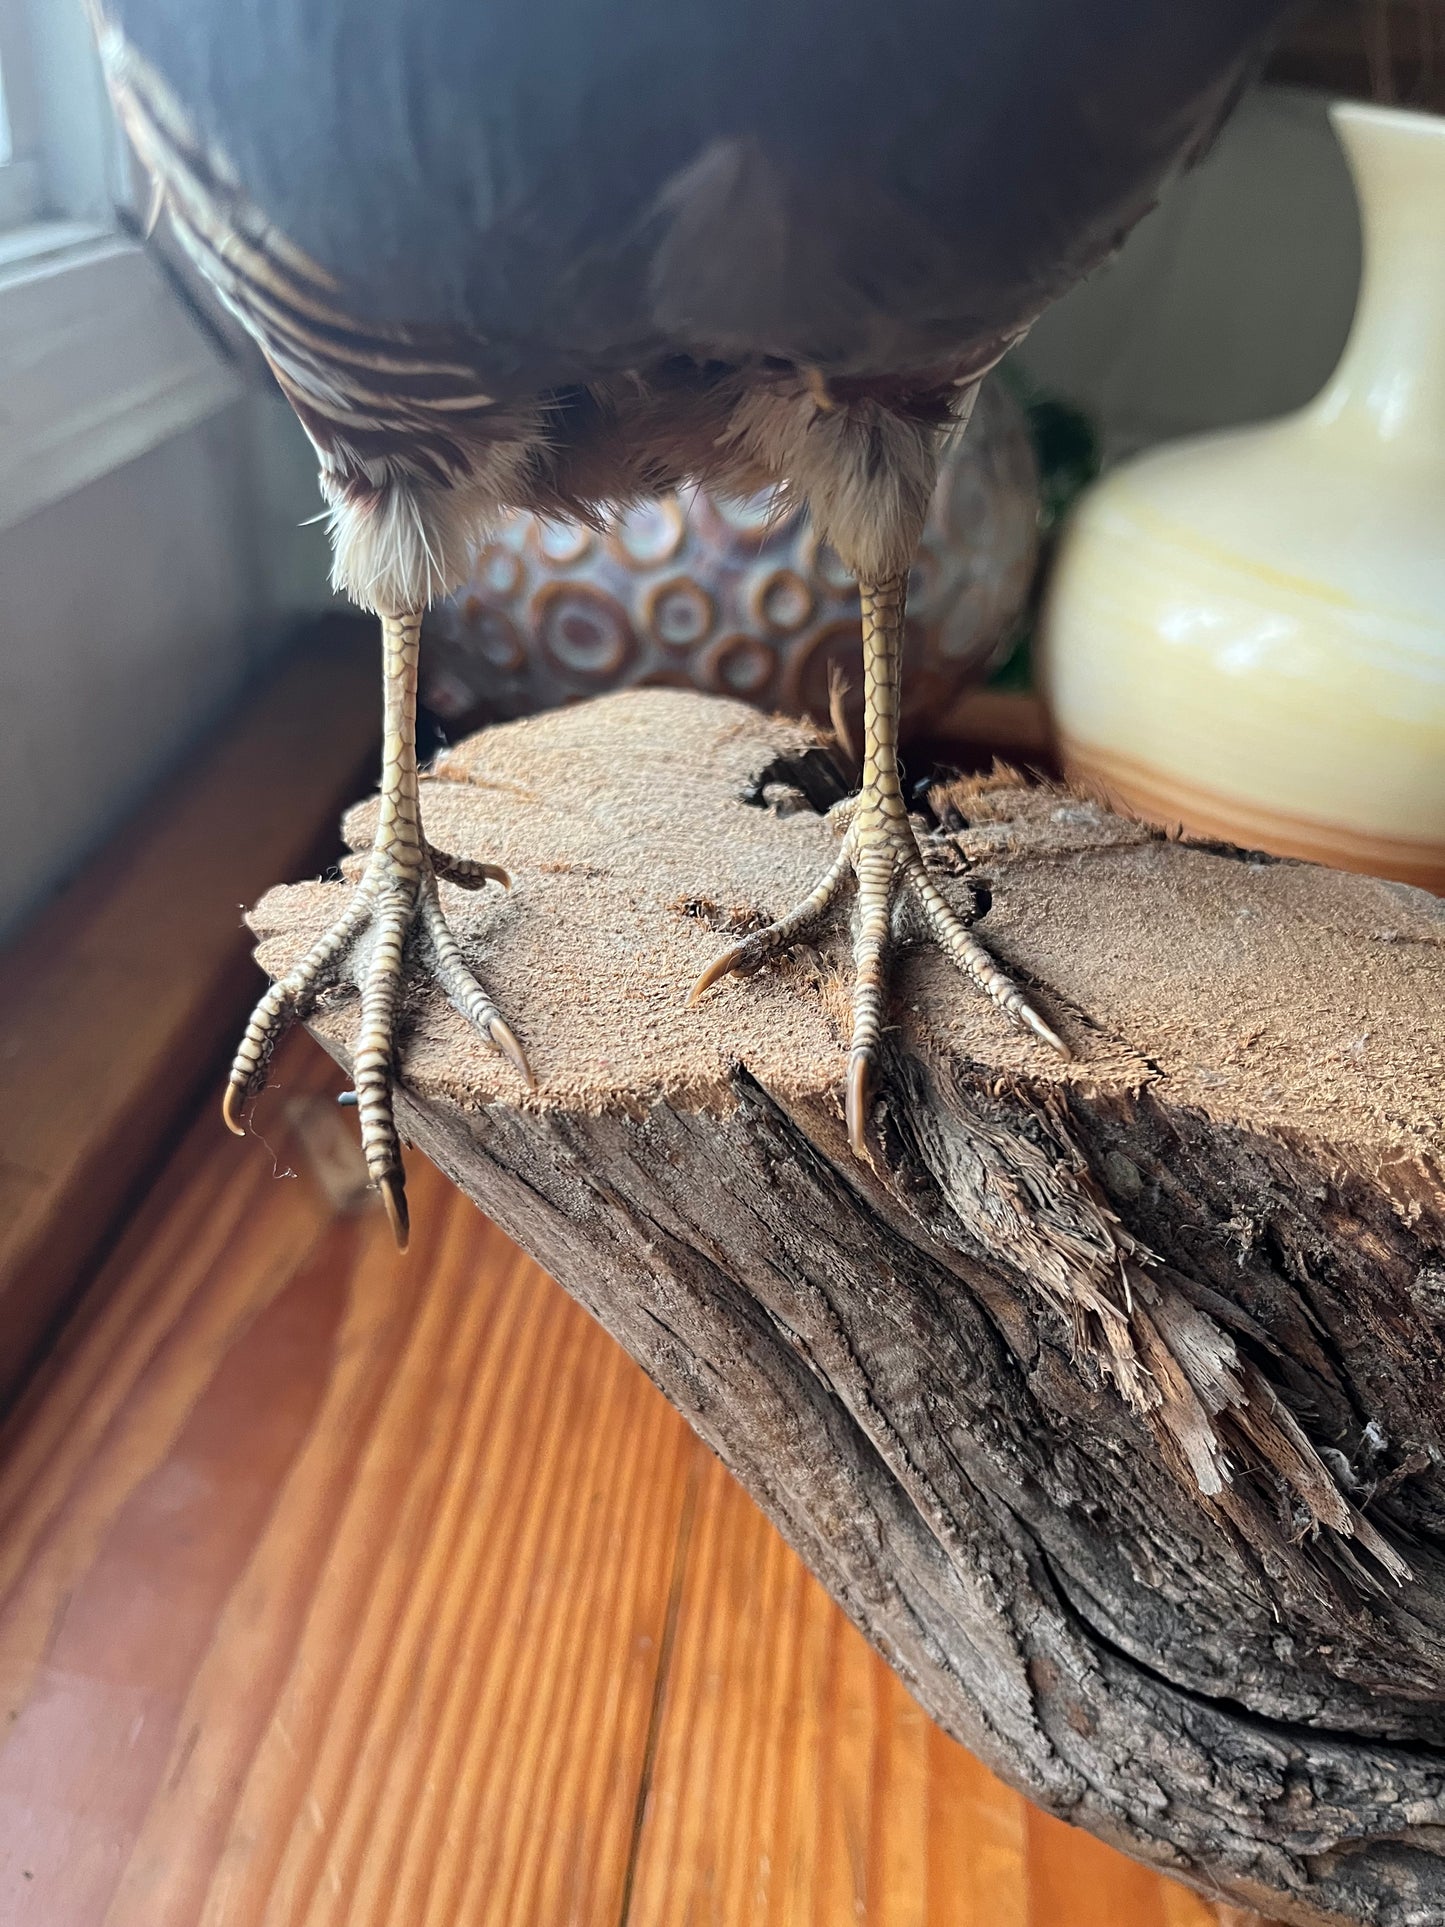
top-left (254, 690), bottom-right (1445, 1927)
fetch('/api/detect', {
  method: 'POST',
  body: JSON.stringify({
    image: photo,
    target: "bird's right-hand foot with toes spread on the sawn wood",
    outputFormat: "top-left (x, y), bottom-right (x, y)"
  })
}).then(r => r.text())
top-left (688, 792), bottom-right (1071, 1158)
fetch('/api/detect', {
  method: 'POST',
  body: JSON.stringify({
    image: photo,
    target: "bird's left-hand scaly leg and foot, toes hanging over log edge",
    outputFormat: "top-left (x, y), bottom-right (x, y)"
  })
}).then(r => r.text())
top-left (223, 615), bottom-right (532, 1251)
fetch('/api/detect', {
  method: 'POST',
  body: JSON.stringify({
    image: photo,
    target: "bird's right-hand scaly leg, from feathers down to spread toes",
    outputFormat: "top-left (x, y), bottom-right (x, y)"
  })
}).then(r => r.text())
top-left (690, 574), bottom-right (1069, 1156)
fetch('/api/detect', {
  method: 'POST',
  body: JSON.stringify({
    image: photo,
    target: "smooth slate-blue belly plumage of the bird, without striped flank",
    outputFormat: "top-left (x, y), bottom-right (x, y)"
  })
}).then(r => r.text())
top-left (104, 0), bottom-right (1279, 362)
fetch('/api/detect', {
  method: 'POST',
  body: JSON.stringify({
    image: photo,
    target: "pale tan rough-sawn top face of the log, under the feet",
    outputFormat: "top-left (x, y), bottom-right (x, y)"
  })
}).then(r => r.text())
top-left (250, 690), bottom-right (1445, 1172)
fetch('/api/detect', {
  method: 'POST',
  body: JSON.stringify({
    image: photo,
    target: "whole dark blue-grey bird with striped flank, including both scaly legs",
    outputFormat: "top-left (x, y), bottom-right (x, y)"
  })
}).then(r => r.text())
top-left (92, 0), bottom-right (1285, 1216)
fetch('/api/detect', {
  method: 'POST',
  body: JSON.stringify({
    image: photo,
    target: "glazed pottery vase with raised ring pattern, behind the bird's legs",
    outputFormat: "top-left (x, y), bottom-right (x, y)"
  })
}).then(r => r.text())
top-left (422, 380), bottom-right (1038, 734)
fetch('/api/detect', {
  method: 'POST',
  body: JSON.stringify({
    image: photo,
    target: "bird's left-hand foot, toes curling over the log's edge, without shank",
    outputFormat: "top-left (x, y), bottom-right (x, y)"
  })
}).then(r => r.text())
top-left (223, 844), bottom-right (532, 1251)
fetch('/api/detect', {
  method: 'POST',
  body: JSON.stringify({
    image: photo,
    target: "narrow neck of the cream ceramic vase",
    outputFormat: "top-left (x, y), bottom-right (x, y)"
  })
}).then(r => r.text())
top-left (1310, 104), bottom-right (1445, 462)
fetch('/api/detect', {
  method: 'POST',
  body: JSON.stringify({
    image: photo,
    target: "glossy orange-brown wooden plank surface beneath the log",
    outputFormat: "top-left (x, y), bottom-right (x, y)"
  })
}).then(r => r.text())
top-left (0, 1039), bottom-right (1271, 1927)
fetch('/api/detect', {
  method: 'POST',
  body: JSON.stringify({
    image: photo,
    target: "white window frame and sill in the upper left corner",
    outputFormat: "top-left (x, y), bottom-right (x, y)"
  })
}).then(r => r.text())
top-left (0, 0), bottom-right (243, 530)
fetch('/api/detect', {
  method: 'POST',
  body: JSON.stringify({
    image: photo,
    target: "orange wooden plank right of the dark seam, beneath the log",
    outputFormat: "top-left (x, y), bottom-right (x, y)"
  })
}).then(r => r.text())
top-left (628, 1459), bottom-right (1240, 1927)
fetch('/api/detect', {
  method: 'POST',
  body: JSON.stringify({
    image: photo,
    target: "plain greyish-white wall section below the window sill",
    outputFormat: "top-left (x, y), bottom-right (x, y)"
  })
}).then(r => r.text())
top-left (0, 403), bottom-right (274, 933)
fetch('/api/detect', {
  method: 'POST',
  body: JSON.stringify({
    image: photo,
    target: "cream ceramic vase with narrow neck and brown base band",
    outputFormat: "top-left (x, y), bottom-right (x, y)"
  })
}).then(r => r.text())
top-left (1042, 104), bottom-right (1445, 892)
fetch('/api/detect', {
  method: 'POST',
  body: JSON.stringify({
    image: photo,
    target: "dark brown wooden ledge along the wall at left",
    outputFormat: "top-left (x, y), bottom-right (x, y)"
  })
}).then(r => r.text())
top-left (0, 624), bottom-right (380, 1403)
